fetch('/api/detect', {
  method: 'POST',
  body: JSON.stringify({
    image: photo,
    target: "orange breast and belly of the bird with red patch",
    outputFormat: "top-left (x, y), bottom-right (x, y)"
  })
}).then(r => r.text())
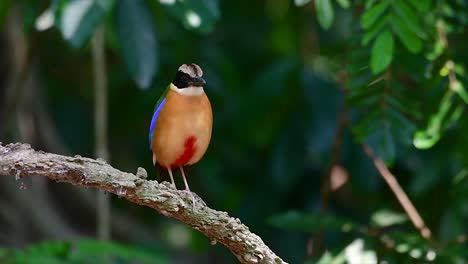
top-left (151, 90), bottom-right (213, 168)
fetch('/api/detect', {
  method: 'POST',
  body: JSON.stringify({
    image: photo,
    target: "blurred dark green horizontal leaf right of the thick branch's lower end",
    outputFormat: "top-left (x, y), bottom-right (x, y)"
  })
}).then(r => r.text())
top-left (269, 211), bottom-right (357, 232)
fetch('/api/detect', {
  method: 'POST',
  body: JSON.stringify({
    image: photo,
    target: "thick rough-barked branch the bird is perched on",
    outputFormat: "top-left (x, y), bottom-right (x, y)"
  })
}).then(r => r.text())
top-left (0, 143), bottom-right (286, 263)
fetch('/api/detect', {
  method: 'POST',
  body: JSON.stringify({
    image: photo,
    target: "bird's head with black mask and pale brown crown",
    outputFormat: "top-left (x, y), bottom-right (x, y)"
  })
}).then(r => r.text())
top-left (172, 63), bottom-right (206, 89)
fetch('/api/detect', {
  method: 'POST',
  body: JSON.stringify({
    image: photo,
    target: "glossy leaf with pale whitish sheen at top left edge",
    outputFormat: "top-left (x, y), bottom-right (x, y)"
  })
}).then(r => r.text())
top-left (58, 0), bottom-right (114, 48)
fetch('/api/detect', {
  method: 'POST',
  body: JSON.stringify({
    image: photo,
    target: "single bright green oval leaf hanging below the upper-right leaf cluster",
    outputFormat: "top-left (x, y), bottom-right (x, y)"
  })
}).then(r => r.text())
top-left (371, 30), bottom-right (394, 74)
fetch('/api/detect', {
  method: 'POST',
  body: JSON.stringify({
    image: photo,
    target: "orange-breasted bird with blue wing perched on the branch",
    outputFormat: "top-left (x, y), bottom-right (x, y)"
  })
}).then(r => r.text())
top-left (149, 63), bottom-right (213, 205)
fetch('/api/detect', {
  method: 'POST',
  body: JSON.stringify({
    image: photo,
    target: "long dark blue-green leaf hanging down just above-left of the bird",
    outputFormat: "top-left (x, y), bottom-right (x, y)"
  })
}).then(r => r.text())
top-left (117, 0), bottom-right (158, 88)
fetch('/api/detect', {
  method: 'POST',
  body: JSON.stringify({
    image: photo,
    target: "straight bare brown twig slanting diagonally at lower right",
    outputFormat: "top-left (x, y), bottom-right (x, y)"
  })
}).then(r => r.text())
top-left (363, 144), bottom-right (431, 239)
